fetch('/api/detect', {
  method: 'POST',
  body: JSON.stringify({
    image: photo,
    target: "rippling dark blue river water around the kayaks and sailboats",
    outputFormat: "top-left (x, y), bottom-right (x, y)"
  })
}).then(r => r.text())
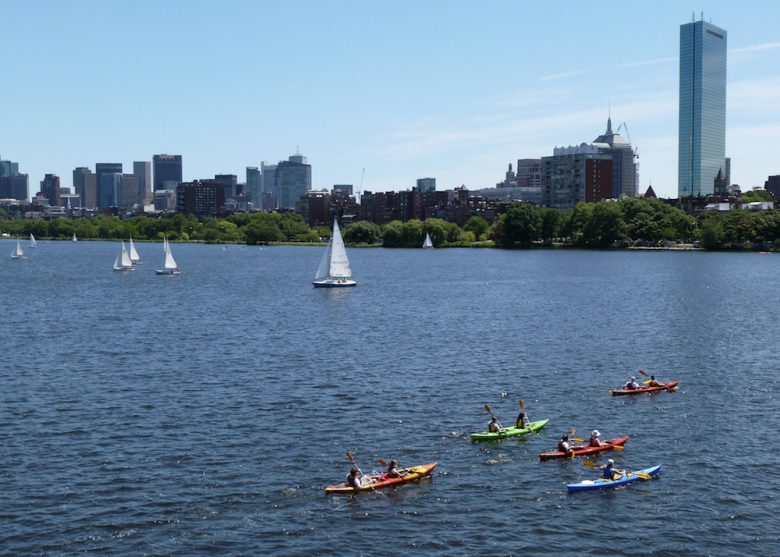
top-left (0, 240), bottom-right (780, 556)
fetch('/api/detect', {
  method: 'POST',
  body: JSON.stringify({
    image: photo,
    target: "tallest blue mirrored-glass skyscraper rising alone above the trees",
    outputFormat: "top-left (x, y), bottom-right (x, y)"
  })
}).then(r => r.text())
top-left (677, 17), bottom-right (727, 197)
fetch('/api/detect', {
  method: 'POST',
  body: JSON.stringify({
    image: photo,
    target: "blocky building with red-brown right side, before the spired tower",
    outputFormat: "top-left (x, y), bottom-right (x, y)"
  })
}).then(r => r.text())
top-left (541, 143), bottom-right (613, 209)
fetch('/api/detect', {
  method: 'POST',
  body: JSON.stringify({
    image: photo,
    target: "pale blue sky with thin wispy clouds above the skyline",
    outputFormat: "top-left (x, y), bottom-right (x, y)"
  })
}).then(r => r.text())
top-left (0, 0), bottom-right (780, 200)
